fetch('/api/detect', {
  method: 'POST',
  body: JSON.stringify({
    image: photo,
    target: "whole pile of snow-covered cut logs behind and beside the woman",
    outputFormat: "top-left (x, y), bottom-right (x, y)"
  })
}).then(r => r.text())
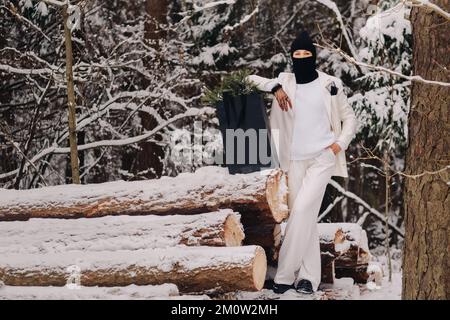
top-left (0, 167), bottom-right (368, 298)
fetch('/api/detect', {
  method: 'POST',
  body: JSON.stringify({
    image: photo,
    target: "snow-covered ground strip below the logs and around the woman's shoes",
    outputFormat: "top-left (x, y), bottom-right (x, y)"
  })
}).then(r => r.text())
top-left (0, 250), bottom-right (402, 300)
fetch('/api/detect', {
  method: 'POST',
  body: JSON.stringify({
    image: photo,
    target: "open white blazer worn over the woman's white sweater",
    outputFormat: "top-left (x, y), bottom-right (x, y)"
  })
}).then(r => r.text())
top-left (247, 70), bottom-right (358, 177)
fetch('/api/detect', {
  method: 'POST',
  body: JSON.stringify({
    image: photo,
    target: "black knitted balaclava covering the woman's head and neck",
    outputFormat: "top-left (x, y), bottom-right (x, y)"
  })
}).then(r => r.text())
top-left (291, 31), bottom-right (319, 83)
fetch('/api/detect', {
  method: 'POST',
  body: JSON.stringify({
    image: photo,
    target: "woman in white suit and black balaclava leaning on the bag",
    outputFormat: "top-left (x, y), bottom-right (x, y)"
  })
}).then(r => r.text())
top-left (249, 31), bottom-right (357, 294)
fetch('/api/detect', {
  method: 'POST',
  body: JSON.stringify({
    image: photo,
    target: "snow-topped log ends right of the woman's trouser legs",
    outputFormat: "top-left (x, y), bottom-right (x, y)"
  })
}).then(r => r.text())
top-left (318, 223), bottom-right (371, 283)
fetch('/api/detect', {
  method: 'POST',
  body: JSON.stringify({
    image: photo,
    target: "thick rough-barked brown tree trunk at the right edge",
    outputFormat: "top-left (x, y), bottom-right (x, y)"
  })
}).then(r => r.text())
top-left (402, 0), bottom-right (450, 299)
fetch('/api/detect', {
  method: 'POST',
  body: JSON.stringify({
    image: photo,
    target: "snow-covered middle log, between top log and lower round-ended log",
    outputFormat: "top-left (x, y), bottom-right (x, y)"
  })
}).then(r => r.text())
top-left (0, 209), bottom-right (244, 255)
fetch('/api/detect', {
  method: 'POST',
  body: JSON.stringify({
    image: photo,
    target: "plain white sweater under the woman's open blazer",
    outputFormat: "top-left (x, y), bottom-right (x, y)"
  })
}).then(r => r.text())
top-left (291, 78), bottom-right (336, 160)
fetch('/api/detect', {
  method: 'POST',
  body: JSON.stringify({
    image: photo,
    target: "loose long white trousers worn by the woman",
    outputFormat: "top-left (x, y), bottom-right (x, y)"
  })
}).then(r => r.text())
top-left (274, 148), bottom-right (336, 291)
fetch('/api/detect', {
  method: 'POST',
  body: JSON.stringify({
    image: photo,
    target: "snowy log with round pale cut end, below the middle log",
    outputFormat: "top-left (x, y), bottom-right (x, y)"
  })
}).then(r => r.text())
top-left (0, 246), bottom-right (267, 292)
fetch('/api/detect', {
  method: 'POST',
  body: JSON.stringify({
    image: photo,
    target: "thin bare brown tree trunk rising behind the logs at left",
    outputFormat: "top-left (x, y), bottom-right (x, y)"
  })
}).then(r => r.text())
top-left (62, 6), bottom-right (80, 184)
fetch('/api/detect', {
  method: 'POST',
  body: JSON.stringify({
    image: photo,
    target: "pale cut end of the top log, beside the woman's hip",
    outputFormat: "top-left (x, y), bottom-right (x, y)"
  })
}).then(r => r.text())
top-left (266, 170), bottom-right (289, 223)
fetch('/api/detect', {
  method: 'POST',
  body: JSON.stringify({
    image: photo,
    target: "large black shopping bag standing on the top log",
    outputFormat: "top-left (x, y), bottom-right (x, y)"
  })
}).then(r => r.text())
top-left (216, 92), bottom-right (275, 174)
